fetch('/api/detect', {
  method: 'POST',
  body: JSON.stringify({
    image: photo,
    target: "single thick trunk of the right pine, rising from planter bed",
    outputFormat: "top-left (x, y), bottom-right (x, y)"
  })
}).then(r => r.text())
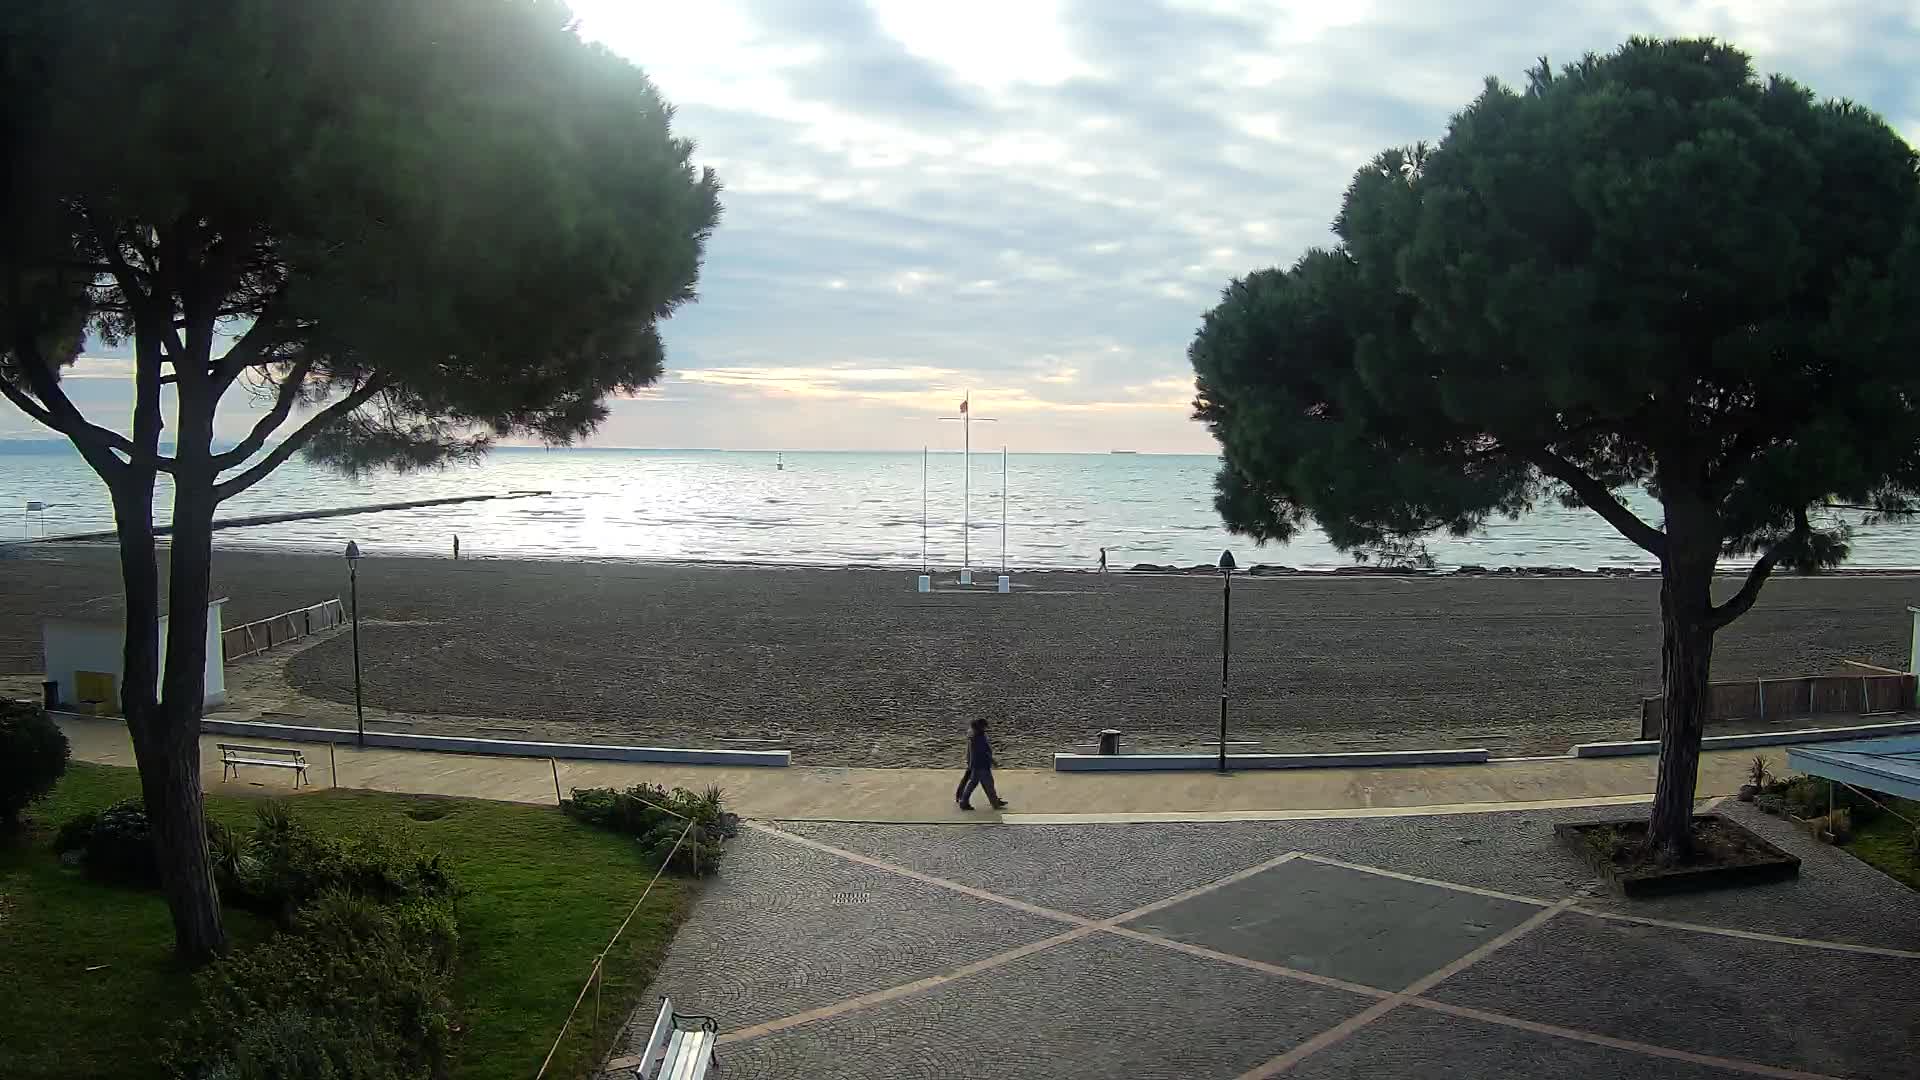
top-left (1649, 517), bottom-right (1718, 859)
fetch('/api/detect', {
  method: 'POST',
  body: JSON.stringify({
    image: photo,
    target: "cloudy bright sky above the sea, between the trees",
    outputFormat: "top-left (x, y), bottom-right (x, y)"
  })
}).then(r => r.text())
top-left (22, 0), bottom-right (1920, 454)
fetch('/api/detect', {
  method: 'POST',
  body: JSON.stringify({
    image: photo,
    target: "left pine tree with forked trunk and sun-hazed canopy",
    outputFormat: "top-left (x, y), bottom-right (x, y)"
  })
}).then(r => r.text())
top-left (0, 0), bottom-right (720, 961)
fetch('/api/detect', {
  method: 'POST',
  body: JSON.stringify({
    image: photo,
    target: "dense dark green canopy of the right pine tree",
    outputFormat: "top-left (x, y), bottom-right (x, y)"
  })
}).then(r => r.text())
top-left (1188, 38), bottom-right (1920, 849)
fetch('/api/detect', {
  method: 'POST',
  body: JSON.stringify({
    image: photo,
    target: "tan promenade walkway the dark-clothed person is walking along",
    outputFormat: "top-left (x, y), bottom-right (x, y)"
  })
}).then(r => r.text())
top-left (60, 717), bottom-right (1786, 824)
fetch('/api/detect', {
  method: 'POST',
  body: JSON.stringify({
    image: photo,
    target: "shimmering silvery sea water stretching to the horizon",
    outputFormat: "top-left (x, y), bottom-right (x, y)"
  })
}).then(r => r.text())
top-left (0, 446), bottom-right (1920, 569)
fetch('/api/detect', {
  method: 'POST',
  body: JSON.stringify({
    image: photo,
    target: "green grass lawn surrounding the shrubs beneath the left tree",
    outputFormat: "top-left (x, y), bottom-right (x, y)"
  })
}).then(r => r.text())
top-left (0, 763), bottom-right (693, 1080)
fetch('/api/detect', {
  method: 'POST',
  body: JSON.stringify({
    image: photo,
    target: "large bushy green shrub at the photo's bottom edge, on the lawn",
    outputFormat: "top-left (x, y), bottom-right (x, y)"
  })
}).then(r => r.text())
top-left (167, 890), bottom-right (459, 1080)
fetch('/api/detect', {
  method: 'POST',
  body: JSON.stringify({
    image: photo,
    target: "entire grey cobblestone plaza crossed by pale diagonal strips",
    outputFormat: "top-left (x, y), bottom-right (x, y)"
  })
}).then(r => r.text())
top-left (609, 805), bottom-right (1920, 1080)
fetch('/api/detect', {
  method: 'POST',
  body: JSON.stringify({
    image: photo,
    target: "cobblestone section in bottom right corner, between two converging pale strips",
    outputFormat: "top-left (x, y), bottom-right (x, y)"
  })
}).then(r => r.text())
top-left (1428, 913), bottom-right (1920, 1078)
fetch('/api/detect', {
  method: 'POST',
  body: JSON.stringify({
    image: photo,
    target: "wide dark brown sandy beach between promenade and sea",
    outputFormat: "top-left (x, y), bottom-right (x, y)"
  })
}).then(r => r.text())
top-left (0, 548), bottom-right (1920, 765)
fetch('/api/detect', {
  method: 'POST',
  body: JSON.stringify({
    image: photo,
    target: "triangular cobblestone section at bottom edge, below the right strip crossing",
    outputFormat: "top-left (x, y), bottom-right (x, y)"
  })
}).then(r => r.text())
top-left (1288, 1007), bottom-right (1745, 1080)
